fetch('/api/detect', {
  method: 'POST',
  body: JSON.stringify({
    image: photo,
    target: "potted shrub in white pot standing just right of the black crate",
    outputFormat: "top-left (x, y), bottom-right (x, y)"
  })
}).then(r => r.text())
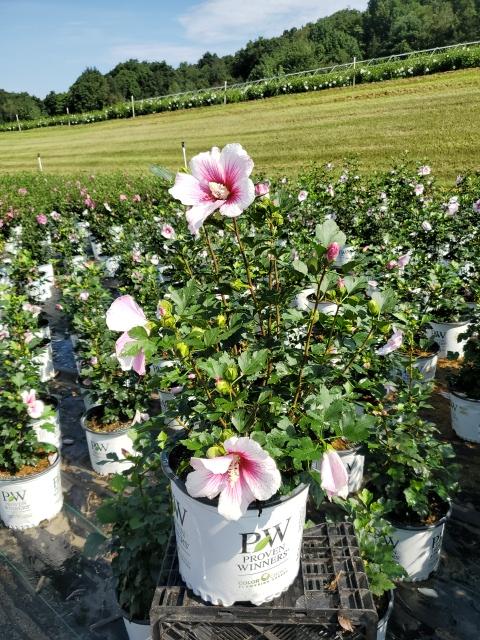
top-left (368, 410), bottom-right (456, 580)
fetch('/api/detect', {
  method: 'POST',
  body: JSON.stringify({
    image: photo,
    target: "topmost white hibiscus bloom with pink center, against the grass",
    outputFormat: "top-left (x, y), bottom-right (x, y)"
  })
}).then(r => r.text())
top-left (169, 143), bottom-right (255, 235)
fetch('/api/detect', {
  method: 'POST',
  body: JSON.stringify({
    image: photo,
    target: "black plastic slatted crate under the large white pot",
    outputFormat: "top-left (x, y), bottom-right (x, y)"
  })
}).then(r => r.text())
top-left (150, 523), bottom-right (378, 640)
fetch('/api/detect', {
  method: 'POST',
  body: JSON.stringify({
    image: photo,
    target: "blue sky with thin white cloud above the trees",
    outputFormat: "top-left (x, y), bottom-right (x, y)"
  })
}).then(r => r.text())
top-left (0, 0), bottom-right (367, 98)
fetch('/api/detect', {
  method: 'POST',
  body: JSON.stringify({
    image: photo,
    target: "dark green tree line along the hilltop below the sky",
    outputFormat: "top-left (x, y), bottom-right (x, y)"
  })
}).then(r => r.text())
top-left (0, 0), bottom-right (480, 122)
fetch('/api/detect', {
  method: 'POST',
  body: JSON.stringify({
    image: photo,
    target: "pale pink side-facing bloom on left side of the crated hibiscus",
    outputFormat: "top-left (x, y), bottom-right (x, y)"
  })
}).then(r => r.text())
top-left (106, 296), bottom-right (148, 376)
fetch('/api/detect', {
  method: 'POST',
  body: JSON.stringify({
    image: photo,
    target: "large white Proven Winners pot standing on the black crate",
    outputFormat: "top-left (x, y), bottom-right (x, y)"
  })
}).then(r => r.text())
top-left (162, 449), bottom-right (308, 606)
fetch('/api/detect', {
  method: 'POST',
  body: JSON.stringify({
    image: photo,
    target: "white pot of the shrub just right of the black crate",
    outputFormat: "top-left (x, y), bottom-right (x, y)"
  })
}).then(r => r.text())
top-left (391, 507), bottom-right (452, 582)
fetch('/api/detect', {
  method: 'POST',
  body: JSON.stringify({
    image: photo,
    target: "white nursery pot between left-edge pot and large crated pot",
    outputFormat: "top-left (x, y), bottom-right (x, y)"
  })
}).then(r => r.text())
top-left (80, 405), bottom-right (135, 476)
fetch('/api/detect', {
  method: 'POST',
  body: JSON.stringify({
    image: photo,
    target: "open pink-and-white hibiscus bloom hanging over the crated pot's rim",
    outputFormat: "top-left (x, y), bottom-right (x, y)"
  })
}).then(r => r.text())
top-left (186, 436), bottom-right (282, 520)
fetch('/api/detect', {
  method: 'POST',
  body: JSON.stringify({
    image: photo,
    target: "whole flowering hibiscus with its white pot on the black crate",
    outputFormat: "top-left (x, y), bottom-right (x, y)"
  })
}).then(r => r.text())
top-left (107, 145), bottom-right (400, 605)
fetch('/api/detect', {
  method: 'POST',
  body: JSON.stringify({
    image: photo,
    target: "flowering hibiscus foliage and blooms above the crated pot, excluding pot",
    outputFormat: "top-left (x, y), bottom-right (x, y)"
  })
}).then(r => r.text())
top-left (107, 145), bottom-right (401, 519)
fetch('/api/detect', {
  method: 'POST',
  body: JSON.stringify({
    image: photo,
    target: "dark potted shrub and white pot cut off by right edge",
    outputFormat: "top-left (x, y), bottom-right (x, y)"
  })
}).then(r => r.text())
top-left (449, 314), bottom-right (480, 442)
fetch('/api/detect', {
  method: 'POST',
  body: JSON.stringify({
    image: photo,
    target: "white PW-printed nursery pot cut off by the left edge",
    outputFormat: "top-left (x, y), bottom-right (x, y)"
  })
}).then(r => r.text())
top-left (0, 453), bottom-right (63, 529)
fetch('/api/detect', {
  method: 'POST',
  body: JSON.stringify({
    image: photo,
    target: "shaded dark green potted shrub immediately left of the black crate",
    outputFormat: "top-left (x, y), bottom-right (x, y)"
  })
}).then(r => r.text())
top-left (85, 424), bottom-right (172, 640)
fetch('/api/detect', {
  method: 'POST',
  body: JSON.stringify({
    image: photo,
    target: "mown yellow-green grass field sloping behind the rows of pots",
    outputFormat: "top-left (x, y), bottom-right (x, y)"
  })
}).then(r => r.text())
top-left (0, 69), bottom-right (480, 182)
